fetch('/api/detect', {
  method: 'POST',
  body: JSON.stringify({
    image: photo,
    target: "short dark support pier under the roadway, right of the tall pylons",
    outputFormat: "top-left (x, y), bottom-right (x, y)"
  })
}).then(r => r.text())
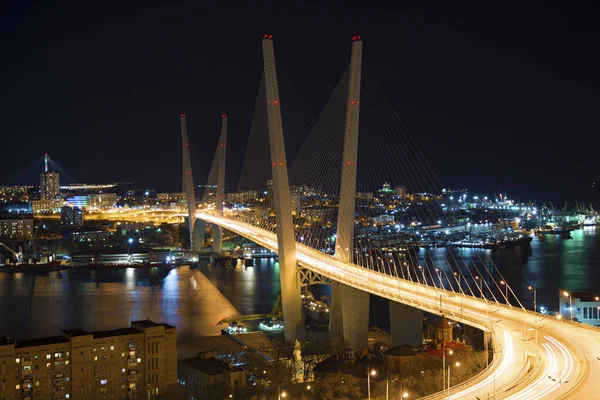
top-left (389, 300), bottom-right (423, 347)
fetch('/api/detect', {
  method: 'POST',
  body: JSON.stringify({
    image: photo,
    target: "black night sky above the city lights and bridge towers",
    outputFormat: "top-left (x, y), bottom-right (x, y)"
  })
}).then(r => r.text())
top-left (0, 0), bottom-right (600, 205)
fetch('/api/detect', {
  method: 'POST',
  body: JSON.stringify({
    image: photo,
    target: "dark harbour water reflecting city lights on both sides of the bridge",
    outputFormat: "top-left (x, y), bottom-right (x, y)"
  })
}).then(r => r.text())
top-left (0, 228), bottom-right (600, 339)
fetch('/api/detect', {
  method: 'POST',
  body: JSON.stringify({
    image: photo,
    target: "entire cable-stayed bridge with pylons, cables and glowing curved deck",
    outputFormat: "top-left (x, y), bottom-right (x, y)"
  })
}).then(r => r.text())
top-left (181, 35), bottom-right (600, 399)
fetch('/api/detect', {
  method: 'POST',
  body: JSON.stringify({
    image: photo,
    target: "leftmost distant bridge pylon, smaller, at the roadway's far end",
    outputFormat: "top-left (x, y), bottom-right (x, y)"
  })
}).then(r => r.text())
top-left (180, 114), bottom-right (205, 251)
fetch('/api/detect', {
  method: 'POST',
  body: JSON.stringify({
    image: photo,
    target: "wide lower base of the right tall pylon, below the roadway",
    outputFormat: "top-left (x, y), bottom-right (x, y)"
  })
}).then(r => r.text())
top-left (329, 282), bottom-right (370, 353)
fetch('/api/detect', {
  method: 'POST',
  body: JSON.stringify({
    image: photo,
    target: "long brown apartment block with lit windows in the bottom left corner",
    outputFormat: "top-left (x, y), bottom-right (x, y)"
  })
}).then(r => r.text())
top-left (0, 320), bottom-right (177, 400)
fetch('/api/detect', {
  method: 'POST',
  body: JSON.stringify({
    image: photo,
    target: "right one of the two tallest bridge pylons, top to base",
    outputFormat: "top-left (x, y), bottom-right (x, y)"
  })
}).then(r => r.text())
top-left (329, 36), bottom-right (369, 352)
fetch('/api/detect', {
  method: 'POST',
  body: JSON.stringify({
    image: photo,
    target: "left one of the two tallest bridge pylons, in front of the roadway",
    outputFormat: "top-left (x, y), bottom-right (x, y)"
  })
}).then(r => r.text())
top-left (262, 35), bottom-right (305, 342)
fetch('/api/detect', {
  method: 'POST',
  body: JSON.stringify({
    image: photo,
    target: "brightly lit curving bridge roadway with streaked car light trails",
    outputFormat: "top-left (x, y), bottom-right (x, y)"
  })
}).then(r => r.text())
top-left (197, 213), bottom-right (600, 400)
